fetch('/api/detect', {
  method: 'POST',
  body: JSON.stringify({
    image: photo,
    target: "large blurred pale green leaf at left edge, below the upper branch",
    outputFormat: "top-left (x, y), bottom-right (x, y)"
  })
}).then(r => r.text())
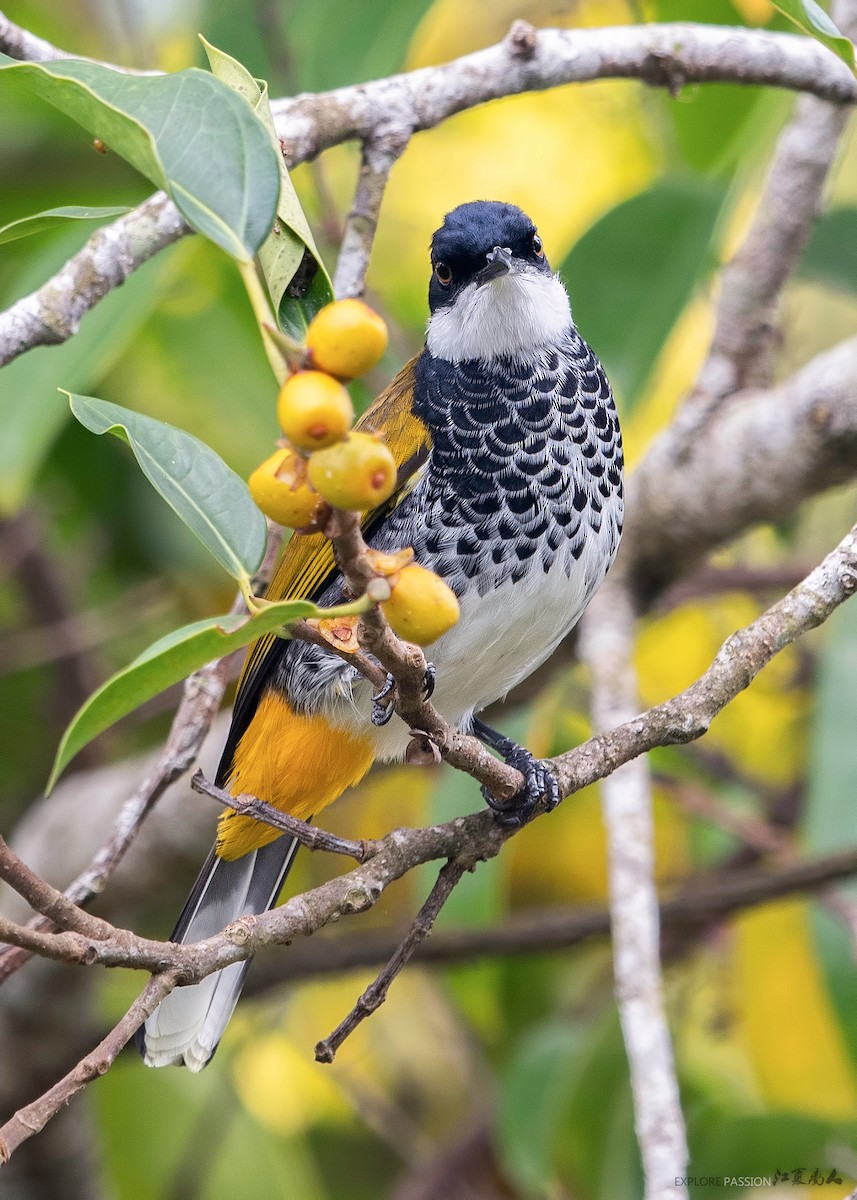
top-left (0, 246), bottom-right (174, 516)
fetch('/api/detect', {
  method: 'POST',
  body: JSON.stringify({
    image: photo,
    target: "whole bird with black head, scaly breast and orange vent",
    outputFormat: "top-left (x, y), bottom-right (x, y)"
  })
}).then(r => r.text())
top-left (137, 200), bottom-right (623, 1072)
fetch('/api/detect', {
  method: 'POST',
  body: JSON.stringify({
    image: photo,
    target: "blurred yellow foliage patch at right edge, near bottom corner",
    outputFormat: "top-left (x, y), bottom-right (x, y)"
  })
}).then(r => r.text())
top-left (733, 900), bottom-right (857, 1121)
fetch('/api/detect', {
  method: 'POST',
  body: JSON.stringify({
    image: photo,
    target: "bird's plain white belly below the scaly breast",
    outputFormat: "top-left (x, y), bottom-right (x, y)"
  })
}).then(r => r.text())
top-left (330, 530), bottom-right (610, 761)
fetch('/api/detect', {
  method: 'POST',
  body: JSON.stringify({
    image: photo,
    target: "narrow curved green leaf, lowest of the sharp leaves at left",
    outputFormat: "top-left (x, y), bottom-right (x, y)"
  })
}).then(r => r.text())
top-left (47, 600), bottom-right (316, 791)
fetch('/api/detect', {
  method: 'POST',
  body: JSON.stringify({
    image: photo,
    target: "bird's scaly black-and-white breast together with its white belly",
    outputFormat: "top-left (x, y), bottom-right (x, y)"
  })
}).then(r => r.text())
top-left (329, 325), bottom-right (623, 758)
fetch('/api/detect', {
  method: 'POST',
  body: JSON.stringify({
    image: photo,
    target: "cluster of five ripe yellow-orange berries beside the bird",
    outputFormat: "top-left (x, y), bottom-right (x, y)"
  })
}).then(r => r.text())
top-left (248, 300), bottom-right (459, 649)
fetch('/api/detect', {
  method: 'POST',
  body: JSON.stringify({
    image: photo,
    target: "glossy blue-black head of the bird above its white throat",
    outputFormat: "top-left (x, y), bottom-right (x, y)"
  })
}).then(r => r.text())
top-left (429, 200), bottom-right (551, 313)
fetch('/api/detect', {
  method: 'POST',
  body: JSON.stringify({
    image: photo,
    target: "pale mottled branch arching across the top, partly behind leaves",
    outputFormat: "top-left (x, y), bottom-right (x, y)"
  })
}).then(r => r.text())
top-left (0, 18), bottom-right (857, 365)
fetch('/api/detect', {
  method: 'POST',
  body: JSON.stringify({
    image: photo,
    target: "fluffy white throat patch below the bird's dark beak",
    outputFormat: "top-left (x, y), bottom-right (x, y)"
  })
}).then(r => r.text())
top-left (426, 271), bottom-right (571, 362)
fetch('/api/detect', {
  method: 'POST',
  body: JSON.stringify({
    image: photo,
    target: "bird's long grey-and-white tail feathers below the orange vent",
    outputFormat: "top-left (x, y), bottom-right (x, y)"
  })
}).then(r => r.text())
top-left (137, 838), bottom-right (298, 1072)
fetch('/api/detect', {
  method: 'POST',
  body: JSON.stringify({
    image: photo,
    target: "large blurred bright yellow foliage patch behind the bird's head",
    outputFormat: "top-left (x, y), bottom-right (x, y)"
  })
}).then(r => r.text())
top-left (370, 0), bottom-right (657, 323)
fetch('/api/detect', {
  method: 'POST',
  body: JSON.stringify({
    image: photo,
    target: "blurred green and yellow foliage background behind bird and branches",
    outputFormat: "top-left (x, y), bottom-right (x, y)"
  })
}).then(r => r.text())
top-left (0, 0), bottom-right (857, 1200)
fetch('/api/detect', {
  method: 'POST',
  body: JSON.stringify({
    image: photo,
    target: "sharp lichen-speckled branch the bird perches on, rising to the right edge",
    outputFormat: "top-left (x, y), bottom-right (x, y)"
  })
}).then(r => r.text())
top-left (0, 527), bottom-right (857, 1157)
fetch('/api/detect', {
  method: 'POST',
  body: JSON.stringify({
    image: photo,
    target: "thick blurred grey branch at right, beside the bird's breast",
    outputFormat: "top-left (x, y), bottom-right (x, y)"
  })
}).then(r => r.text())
top-left (615, 338), bottom-right (857, 600)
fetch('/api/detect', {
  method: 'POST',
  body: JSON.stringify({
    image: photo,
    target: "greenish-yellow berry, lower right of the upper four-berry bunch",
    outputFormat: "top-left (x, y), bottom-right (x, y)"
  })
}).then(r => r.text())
top-left (308, 432), bottom-right (396, 512)
